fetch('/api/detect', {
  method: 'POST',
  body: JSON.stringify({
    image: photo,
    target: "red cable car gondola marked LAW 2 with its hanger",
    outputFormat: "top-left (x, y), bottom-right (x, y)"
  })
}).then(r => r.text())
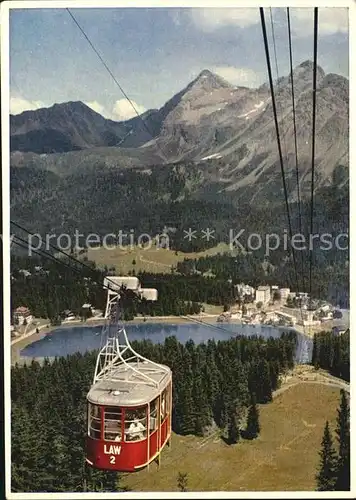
top-left (86, 276), bottom-right (172, 472)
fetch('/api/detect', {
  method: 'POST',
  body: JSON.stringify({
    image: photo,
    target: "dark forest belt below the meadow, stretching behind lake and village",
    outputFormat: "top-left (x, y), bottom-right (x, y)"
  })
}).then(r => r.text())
top-left (11, 250), bottom-right (349, 323)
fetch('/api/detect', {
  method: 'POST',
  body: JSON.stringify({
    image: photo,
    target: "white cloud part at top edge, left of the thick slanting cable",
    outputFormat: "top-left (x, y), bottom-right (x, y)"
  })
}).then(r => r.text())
top-left (191, 8), bottom-right (260, 31)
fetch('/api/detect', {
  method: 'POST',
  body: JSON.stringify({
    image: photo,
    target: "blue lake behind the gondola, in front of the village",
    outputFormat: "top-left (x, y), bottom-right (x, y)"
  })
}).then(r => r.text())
top-left (21, 323), bottom-right (313, 363)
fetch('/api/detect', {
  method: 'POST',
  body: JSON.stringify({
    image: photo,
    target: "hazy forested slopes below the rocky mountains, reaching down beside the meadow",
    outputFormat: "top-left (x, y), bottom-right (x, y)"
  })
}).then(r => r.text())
top-left (11, 158), bottom-right (349, 307)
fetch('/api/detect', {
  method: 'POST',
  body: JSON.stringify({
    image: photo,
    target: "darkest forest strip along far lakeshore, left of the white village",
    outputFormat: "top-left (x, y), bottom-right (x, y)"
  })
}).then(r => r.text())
top-left (11, 258), bottom-right (236, 324)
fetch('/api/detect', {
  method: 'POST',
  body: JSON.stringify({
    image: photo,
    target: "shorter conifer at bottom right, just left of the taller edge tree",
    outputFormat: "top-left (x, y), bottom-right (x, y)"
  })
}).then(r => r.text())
top-left (316, 421), bottom-right (337, 491)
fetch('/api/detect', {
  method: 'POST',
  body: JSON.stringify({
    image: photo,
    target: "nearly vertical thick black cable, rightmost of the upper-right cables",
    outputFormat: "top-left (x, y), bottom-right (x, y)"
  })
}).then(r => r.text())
top-left (309, 7), bottom-right (318, 297)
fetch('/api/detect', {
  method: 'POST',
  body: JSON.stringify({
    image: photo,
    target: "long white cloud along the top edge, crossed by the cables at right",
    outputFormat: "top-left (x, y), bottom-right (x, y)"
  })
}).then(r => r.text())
top-left (191, 7), bottom-right (349, 37)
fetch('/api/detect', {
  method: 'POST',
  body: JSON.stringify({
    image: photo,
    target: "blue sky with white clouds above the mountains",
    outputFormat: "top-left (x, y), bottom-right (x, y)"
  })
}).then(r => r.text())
top-left (10, 7), bottom-right (349, 120)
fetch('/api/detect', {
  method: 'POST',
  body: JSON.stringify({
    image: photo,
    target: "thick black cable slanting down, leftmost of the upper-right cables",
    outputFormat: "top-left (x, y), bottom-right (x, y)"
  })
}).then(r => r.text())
top-left (260, 7), bottom-right (299, 293)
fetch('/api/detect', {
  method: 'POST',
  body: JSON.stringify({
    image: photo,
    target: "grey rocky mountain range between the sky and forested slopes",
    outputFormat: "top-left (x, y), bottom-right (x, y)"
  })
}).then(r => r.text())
top-left (10, 61), bottom-right (349, 203)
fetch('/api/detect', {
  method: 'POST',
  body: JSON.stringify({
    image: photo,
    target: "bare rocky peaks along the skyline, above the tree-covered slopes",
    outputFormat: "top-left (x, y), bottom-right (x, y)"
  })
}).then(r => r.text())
top-left (11, 60), bottom-right (349, 197)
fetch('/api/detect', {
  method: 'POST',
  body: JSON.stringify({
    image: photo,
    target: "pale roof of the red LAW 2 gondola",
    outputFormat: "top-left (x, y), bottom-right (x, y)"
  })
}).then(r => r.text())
top-left (87, 362), bottom-right (171, 406)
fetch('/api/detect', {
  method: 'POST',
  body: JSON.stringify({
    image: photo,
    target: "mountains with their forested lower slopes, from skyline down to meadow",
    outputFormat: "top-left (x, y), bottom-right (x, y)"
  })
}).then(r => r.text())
top-left (10, 61), bottom-right (349, 242)
